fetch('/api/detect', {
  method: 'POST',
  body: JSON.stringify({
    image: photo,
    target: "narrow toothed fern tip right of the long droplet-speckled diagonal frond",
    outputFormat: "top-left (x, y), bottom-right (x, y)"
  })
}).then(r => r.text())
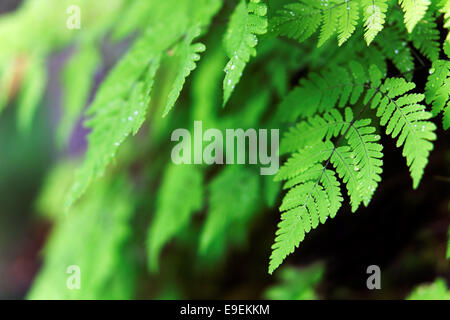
top-left (163, 27), bottom-right (206, 117)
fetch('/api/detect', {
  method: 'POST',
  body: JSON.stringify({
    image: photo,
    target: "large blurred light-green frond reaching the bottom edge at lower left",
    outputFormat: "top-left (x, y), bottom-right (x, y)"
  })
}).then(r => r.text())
top-left (28, 178), bottom-right (135, 299)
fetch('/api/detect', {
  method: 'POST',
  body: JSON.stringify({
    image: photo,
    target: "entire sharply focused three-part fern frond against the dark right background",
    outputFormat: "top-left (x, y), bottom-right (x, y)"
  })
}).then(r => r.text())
top-left (269, 62), bottom-right (436, 273)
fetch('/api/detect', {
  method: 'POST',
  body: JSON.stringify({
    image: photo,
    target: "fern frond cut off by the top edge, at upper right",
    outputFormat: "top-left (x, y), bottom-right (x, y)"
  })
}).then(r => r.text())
top-left (271, 0), bottom-right (449, 46)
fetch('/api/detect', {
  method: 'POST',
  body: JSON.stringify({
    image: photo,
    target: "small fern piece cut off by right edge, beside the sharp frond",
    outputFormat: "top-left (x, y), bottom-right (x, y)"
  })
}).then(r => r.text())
top-left (425, 60), bottom-right (450, 130)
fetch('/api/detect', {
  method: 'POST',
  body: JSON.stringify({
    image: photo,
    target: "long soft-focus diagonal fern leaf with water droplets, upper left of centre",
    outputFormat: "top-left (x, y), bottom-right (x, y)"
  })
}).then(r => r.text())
top-left (67, 39), bottom-right (160, 208)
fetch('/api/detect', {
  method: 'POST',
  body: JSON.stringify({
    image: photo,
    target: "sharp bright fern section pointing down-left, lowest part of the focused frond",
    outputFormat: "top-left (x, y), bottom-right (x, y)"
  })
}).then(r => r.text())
top-left (269, 141), bottom-right (342, 274)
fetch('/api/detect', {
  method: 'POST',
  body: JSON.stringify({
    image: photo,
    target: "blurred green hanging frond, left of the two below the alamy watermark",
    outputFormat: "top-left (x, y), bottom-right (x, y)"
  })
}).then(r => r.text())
top-left (147, 164), bottom-right (203, 271)
